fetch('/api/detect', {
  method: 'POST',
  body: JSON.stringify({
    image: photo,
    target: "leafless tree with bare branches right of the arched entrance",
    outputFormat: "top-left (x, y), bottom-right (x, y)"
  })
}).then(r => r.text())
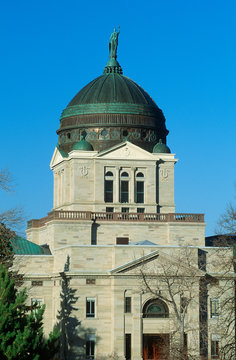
top-left (141, 247), bottom-right (205, 360)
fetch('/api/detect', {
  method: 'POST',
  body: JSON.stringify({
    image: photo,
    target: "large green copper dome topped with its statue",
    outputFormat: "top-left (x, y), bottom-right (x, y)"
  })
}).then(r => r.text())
top-left (57, 30), bottom-right (168, 153)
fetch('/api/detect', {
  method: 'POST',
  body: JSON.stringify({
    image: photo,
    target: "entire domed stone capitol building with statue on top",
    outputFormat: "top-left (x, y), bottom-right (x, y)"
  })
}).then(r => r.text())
top-left (16, 30), bottom-right (232, 360)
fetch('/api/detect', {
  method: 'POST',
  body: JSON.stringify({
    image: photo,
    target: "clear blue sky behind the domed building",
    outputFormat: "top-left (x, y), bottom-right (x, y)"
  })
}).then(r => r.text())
top-left (0, 0), bottom-right (236, 235)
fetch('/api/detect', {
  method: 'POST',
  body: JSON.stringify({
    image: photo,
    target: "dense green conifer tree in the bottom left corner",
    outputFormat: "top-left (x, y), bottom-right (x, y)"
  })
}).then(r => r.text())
top-left (0, 264), bottom-right (60, 360)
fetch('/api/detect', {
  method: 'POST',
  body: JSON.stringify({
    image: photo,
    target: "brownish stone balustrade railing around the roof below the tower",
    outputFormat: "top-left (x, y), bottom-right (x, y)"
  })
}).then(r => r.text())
top-left (27, 210), bottom-right (204, 229)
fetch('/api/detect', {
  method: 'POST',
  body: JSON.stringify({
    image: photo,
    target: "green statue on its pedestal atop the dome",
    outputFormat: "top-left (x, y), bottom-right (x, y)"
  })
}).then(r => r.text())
top-left (104, 26), bottom-right (123, 74)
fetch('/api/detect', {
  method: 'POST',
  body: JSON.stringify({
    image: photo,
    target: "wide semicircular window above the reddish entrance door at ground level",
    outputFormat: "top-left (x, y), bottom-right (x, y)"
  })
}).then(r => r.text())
top-left (143, 299), bottom-right (169, 318)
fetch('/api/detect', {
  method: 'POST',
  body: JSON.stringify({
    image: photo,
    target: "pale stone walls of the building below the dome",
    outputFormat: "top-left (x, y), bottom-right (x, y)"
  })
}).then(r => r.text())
top-left (13, 136), bottom-right (233, 360)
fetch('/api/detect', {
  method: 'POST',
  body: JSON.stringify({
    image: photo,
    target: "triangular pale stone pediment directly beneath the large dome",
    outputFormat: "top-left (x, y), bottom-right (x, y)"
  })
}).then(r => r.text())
top-left (98, 141), bottom-right (154, 160)
